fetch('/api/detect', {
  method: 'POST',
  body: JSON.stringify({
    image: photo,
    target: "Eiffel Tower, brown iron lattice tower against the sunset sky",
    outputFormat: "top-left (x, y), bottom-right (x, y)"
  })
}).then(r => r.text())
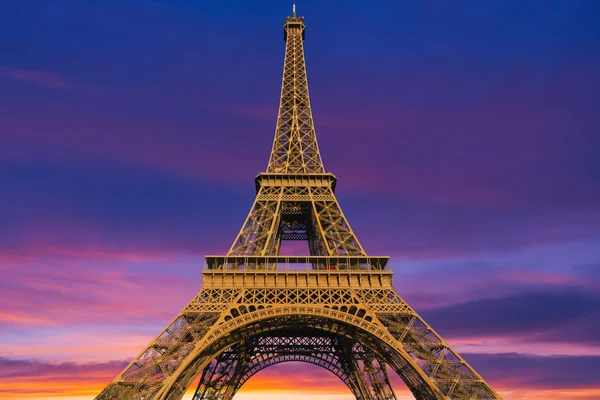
top-left (96, 6), bottom-right (500, 400)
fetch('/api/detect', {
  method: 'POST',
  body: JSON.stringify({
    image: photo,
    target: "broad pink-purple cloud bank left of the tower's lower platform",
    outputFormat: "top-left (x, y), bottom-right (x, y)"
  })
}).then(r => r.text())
top-left (0, 258), bottom-right (202, 334)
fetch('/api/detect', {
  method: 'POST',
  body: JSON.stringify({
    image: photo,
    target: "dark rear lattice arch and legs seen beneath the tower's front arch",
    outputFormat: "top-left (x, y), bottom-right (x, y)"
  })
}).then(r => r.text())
top-left (193, 331), bottom-right (396, 400)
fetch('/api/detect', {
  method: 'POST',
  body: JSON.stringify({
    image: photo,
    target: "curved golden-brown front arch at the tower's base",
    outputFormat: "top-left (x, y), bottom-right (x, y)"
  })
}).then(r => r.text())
top-left (156, 306), bottom-right (445, 400)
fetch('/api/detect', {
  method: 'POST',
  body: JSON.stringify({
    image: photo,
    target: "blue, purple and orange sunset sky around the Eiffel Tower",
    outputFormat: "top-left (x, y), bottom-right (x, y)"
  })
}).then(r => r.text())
top-left (0, 0), bottom-right (600, 400)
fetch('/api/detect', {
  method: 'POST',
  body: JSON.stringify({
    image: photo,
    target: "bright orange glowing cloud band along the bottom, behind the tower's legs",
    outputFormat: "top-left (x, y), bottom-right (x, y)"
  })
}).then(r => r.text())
top-left (0, 358), bottom-right (600, 400)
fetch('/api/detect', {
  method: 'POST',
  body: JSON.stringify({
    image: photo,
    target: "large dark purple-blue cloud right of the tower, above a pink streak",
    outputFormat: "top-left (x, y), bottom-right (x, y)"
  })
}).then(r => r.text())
top-left (421, 287), bottom-right (600, 346)
